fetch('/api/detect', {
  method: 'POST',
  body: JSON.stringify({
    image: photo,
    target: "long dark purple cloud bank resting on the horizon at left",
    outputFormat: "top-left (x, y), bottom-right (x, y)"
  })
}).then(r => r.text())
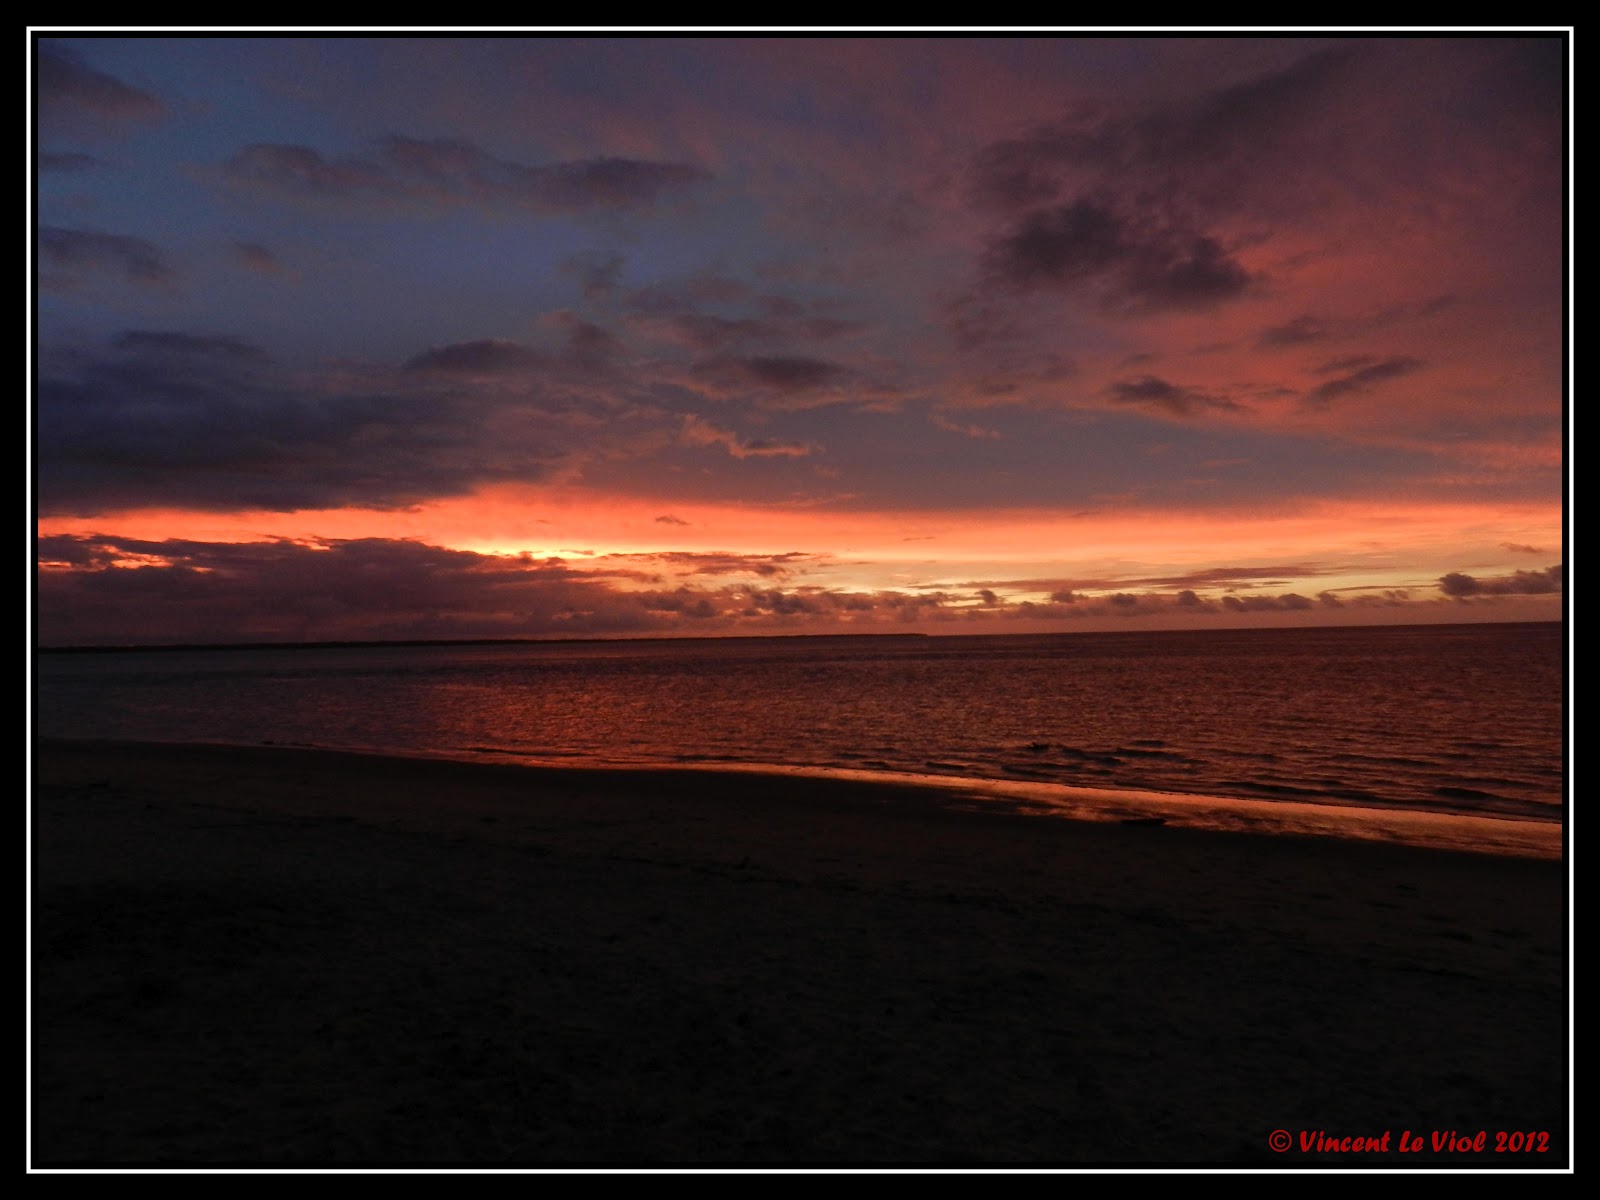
top-left (38, 536), bottom-right (949, 645)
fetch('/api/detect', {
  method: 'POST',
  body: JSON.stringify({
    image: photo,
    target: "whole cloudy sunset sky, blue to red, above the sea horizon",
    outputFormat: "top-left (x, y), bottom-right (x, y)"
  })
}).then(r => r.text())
top-left (32, 32), bottom-right (1570, 646)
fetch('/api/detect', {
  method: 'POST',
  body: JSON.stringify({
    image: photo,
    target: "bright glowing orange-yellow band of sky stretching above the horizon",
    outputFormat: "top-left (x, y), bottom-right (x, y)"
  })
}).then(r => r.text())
top-left (38, 485), bottom-right (1562, 604)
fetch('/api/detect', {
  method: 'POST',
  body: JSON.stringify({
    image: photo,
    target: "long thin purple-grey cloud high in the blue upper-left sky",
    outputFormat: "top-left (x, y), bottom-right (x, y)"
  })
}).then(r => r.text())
top-left (224, 134), bottom-right (710, 213)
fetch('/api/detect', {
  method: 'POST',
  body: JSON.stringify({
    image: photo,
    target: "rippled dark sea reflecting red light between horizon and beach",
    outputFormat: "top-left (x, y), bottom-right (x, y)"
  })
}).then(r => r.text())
top-left (35, 624), bottom-right (1566, 853)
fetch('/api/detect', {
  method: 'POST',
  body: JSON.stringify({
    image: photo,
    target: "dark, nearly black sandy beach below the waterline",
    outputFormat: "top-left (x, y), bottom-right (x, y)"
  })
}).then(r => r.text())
top-left (30, 742), bottom-right (1571, 1170)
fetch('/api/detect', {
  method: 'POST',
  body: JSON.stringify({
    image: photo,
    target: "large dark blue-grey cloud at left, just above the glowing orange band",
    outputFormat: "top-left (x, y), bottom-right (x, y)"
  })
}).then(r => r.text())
top-left (37, 331), bottom-right (560, 515)
